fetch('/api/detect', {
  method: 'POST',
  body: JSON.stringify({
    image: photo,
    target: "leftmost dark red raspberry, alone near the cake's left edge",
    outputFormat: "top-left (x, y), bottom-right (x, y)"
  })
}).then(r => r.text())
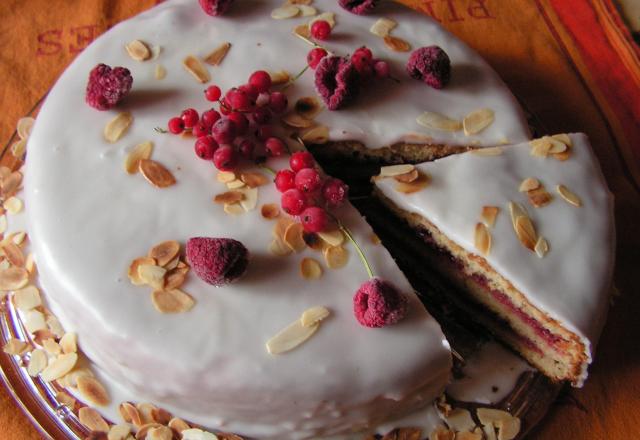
top-left (85, 64), bottom-right (133, 110)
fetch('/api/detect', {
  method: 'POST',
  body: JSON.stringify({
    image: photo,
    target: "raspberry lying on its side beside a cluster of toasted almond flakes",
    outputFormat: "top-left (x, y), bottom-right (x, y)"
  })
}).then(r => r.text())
top-left (187, 237), bottom-right (249, 286)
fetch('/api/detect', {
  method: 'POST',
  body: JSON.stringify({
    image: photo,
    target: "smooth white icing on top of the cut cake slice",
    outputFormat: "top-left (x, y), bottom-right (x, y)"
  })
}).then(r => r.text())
top-left (377, 134), bottom-right (615, 383)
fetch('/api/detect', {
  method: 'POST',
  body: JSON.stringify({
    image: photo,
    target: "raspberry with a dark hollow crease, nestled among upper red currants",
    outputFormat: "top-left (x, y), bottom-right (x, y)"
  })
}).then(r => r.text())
top-left (315, 56), bottom-right (360, 110)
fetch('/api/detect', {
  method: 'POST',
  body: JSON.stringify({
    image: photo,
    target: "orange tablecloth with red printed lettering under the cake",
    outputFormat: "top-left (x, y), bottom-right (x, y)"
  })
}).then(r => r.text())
top-left (0, 0), bottom-right (640, 440)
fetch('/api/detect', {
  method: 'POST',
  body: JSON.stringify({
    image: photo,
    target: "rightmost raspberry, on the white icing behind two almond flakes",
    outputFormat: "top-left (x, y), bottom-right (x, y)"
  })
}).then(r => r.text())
top-left (407, 46), bottom-right (451, 89)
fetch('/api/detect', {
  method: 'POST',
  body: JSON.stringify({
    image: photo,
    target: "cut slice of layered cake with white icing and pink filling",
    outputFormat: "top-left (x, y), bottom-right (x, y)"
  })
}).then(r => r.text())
top-left (375, 134), bottom-right (615, 386)
